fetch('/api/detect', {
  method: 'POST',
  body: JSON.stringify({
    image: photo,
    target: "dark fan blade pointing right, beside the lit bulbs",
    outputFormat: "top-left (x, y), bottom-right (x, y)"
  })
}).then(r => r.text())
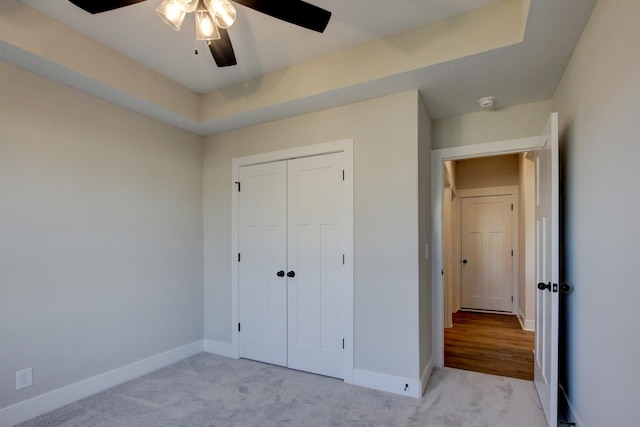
top-left (233, 0), bottom-right (331, 33)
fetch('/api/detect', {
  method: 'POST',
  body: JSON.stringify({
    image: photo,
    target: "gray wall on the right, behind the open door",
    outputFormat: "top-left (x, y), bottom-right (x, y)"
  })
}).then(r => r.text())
top-left (553, 0), bottom-right (640, 426)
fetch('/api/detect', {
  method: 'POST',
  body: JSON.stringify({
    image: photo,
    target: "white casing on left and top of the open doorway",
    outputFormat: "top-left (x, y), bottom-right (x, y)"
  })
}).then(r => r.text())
top-left (431, 136), bottom-right (539, 368)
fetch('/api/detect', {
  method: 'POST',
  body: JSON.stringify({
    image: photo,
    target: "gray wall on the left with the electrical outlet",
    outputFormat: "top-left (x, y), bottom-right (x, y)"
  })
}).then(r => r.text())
top-left (0, 63), bottom-right (203, 408)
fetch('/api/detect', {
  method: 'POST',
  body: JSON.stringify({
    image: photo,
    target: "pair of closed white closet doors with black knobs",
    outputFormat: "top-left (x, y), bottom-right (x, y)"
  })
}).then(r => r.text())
top-left (238, 152), bottom-right (350, 378)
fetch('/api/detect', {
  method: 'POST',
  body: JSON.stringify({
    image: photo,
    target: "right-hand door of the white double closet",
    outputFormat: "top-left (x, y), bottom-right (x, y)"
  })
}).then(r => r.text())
top-left (288, 153), bottom-right (347, 377)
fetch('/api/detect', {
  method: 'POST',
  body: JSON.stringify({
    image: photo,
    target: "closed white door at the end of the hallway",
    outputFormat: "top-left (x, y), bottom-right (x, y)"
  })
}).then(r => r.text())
top-left (460, 195), bottom-right (514, 312)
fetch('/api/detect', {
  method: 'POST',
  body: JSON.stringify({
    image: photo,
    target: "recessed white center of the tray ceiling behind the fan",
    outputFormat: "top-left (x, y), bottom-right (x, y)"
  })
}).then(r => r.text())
top-left (22, 0), bottom-right (502, 93)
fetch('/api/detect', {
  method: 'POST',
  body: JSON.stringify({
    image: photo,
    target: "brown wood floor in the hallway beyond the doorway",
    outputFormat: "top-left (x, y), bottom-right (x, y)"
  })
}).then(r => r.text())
top-left (444, 311), bottom-right (535, 381)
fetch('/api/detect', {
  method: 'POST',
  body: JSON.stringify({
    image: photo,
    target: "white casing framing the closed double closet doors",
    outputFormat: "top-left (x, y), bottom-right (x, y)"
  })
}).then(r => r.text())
top-left (230, 139), bottom-right (354, 383)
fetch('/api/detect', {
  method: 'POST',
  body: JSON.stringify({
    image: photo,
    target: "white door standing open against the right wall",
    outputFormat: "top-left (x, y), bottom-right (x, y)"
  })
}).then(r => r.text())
top-left (532, 113), bottom-right (560, 427)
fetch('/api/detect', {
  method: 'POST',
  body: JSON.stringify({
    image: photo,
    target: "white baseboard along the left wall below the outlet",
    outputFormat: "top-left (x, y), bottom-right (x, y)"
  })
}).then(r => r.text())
top-left (0, 340), bottom-right (203, 427)
